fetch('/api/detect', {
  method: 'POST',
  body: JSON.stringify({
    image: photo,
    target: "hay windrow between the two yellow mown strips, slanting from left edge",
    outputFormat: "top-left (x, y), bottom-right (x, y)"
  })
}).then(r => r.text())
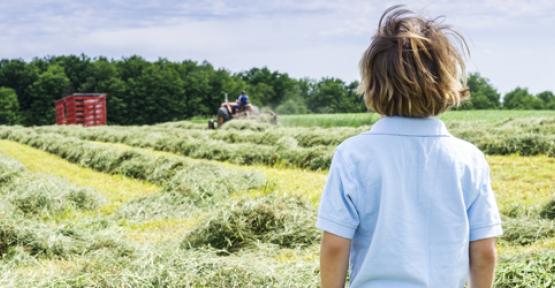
top-left (0, 128), bottom-right (265, 207)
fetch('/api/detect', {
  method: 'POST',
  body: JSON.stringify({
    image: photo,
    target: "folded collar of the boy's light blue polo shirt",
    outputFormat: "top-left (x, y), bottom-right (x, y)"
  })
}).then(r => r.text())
top-left (368, 116), bottom-right (451, 136)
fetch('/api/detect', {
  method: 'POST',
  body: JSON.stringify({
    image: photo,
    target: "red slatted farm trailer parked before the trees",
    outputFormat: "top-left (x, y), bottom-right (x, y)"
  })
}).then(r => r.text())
top-left (56, 93), bottom-right (106, 126)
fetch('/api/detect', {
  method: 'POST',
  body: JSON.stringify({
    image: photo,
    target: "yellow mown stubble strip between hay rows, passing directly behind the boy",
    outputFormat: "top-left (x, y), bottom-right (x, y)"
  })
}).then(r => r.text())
top-left (33, 138), bottom-right (555, 214)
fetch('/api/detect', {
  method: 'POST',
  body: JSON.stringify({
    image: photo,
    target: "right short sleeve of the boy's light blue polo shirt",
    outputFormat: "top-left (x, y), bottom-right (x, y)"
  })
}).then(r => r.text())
top-left (467, 156), bottom-right (503, 241)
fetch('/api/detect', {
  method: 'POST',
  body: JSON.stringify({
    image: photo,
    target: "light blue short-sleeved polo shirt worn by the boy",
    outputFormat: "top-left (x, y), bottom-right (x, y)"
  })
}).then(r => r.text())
top-left (317, 117), bottom-right (502, 288)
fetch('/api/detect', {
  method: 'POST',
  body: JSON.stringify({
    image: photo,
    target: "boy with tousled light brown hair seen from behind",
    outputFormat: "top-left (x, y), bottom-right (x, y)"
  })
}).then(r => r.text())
top-left (317, 6), bottom-right (502, 288)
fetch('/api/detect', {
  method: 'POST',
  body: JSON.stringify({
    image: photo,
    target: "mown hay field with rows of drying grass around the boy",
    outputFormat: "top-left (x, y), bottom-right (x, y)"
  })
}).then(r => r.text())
top-left (0, 111), bottom-right (555, 288)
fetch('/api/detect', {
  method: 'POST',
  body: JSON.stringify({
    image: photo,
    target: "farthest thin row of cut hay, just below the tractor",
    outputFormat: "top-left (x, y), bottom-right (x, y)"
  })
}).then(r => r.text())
top-left (172, 118), bottom-right (555, 156)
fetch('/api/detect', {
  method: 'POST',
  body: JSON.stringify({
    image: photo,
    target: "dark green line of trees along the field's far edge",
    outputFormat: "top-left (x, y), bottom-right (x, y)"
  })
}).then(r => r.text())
top-left (0, 55), bottom-right (555, 125)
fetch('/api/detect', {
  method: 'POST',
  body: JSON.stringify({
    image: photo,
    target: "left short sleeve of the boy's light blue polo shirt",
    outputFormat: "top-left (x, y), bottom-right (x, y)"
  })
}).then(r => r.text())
top-left (316, 150), bottom-right (359, 239)
